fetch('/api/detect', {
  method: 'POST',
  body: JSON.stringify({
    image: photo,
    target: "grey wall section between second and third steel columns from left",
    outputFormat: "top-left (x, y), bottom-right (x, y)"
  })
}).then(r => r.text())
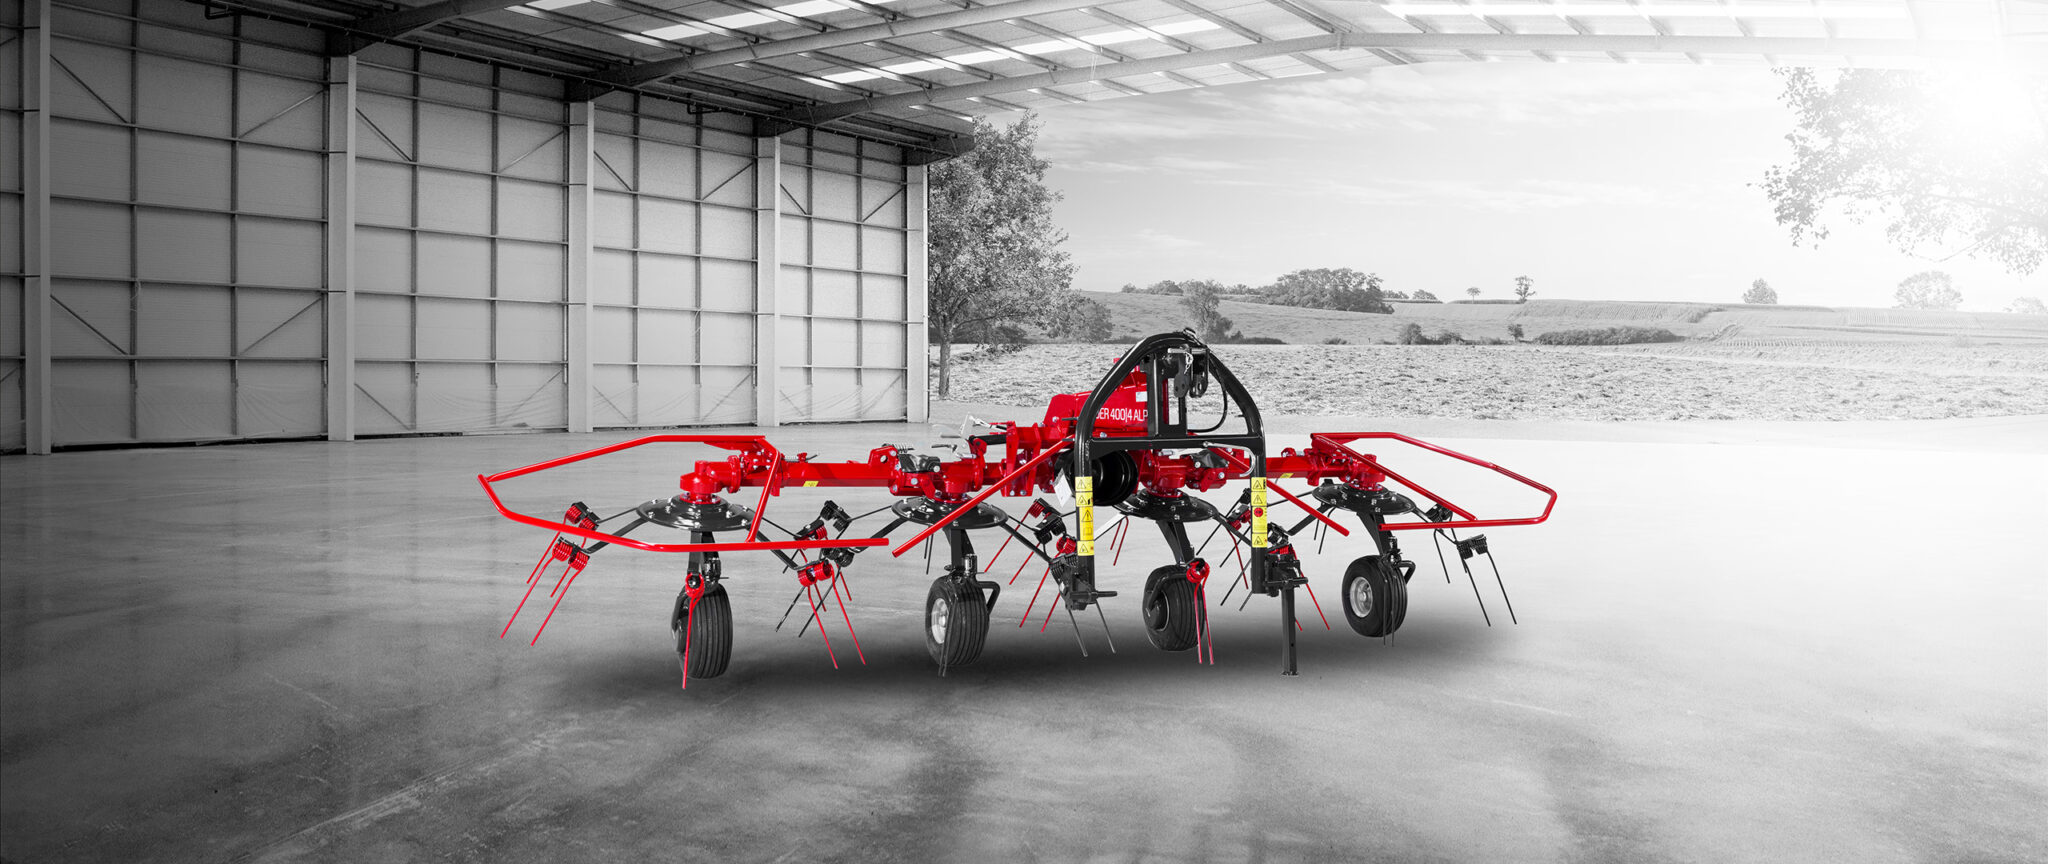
top-left (354, 45), bottom-right (569, 434)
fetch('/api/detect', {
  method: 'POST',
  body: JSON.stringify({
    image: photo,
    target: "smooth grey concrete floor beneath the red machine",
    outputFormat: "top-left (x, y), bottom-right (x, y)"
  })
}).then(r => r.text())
top-left (0, 418), bottom-right (2048, 864)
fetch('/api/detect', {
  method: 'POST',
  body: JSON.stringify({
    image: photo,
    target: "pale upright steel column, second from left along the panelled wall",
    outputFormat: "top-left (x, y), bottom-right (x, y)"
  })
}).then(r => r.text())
top-left (328, 57), bottom-right (356, 440)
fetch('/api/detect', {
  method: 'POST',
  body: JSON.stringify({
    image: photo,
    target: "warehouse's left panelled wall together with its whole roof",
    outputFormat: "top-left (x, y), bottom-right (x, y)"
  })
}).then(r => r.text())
top-left (0, 0), bottom-right (2044, 455)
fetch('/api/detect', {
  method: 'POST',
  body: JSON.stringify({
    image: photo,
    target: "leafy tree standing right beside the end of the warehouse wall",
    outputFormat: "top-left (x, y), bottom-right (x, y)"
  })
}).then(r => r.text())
top-left (928, 115), bottom-right (1073, 399)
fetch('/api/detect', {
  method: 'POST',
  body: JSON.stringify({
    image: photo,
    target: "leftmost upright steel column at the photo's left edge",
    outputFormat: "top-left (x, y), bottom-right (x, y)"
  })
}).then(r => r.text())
top-left (20, 0), bottom-right (51, 455)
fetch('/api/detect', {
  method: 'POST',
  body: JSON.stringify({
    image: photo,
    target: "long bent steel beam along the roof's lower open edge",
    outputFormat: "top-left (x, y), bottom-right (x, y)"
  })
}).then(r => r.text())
top-left (772, 33), bottom-right (2048, 125)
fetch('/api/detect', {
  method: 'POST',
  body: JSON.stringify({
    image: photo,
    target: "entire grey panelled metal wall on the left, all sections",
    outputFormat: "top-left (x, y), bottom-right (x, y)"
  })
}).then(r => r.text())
top-left (0, 0), bottom-right (924, 450)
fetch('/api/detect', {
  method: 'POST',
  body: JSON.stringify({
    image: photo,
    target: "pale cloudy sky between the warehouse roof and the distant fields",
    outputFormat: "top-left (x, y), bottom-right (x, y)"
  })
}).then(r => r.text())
top-left (993, 63), bottom-right (2048, 311)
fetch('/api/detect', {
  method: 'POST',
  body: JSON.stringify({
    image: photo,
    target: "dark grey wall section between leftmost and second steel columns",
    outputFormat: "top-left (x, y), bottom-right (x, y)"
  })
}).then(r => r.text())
top-left (49, 2), bottom-right (326, 444)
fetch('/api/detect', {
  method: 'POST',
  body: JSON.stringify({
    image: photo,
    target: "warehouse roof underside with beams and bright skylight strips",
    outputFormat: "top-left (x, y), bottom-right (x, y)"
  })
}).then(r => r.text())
top-left (207, 0), bottom-right (2048, 149)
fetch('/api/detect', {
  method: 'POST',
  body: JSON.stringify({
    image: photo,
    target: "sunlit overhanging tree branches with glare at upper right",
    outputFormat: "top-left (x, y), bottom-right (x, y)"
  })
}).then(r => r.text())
top-left (1763, 68), bottom-right (2048, 274)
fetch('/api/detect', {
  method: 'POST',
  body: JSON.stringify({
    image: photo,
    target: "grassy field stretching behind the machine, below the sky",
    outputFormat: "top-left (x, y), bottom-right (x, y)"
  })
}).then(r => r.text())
top-left (952, 295), bottom-right (2048, 420)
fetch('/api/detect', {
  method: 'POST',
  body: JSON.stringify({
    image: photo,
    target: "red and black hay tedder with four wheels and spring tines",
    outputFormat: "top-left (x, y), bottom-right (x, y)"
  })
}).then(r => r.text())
top-left (477, 332), bottom-right (1556, 686)
